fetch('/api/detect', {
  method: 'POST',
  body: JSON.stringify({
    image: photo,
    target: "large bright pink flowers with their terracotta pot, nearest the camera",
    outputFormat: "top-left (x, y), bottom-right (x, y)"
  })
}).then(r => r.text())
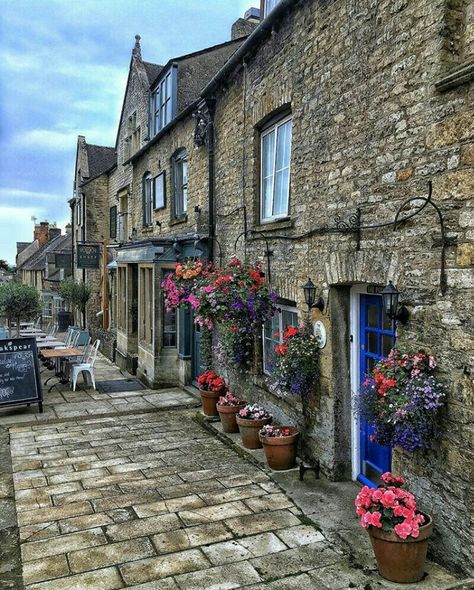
top-left (355, 473), bottom-right (433, 584)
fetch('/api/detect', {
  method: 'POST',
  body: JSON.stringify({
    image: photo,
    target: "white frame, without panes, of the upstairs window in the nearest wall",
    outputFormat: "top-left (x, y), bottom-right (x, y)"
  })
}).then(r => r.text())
top-left (258, 109), bottom-right (293, 225)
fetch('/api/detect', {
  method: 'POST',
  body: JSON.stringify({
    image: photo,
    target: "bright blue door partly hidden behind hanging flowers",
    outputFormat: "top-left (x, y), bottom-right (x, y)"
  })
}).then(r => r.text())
top-left (358, 295), bottom-right (395, 487)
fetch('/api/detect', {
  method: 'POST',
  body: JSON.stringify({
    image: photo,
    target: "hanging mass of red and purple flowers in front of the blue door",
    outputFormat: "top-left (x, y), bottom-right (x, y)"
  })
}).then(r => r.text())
top-left (357, 348), bottom-right (446, 452)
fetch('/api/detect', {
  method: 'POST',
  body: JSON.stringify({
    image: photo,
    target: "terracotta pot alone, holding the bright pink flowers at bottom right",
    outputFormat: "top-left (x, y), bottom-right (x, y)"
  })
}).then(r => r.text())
top-left (368, 514), bottom-right (433, 584)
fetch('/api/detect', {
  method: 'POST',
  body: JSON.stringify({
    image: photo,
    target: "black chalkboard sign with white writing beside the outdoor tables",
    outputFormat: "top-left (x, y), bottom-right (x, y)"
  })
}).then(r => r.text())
top-left (0, 338), bottom-right (43, 412)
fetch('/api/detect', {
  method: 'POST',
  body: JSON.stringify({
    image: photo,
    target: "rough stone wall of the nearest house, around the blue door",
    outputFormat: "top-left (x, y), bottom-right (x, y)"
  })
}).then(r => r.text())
top-left (211, 0), bottom-right (474, 572)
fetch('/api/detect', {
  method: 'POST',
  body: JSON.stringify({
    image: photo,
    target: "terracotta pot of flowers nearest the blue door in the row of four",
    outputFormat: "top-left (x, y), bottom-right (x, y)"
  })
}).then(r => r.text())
top-left (260, 424), bottom-right (300, 471)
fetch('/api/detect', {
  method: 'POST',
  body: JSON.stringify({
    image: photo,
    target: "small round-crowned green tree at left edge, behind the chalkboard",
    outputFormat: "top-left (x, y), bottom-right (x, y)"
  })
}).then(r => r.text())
top-left (0, 281), bottom-right (41, 337)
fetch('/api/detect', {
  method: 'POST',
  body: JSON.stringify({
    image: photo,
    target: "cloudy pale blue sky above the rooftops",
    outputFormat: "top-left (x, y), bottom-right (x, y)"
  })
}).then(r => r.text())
top-left (0, 0), bottom-right (259, 264)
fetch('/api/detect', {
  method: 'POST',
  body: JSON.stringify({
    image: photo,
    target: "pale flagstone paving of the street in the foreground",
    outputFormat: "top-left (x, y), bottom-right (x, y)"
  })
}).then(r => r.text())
top-left (0, 358), bottom-right (471, 590)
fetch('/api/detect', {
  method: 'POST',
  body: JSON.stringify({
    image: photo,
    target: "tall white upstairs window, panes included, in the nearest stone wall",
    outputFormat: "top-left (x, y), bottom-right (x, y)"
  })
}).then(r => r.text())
top-left (260, 118), bottom-right (291, 222)
